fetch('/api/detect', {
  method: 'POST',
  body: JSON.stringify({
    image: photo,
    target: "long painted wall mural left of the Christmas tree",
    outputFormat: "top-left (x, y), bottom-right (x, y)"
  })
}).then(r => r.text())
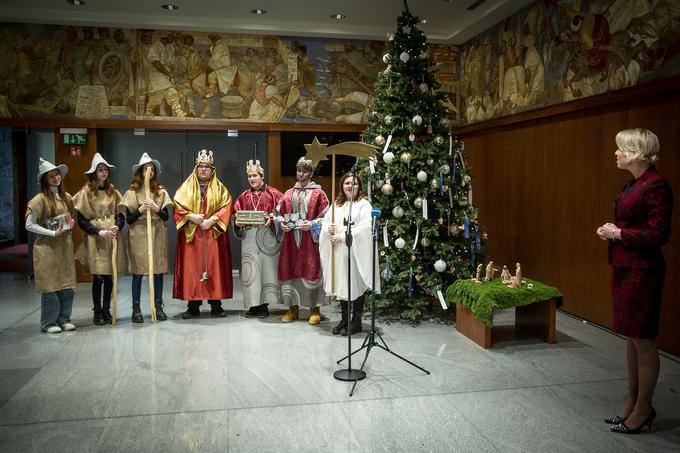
top-left (0, 24), bottom-right (384, 123)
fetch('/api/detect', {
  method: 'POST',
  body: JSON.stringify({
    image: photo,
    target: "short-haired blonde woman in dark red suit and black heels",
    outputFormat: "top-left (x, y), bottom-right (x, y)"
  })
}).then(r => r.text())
top-left (597, 129), bottom-right (673, 434)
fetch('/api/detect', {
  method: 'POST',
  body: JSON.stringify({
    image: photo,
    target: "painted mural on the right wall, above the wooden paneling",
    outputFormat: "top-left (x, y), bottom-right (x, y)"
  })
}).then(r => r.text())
top-left (458, 0), bottom-right (680, 124)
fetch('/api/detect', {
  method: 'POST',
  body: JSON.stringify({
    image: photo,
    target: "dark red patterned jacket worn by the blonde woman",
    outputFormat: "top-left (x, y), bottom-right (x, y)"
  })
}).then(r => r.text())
top-left (609, 166), bottom-right (673, 269)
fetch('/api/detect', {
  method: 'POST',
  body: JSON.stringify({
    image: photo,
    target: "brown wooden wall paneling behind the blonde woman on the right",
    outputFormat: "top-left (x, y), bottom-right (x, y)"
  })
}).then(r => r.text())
top-left (457, 83), bottom-right (680, 354)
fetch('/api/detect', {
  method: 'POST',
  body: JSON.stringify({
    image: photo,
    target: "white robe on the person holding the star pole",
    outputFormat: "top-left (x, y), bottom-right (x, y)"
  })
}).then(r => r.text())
top-left (319, 199), bottom-right (380, 300)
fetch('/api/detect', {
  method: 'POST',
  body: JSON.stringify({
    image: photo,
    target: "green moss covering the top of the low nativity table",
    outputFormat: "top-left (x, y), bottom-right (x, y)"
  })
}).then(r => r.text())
top-left (446, 278), bottom-right (562, 327)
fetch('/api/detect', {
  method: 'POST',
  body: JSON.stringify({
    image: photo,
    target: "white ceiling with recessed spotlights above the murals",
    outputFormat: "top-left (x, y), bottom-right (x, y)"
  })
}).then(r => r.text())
top-left (0, 0), bottom-right (534, 44)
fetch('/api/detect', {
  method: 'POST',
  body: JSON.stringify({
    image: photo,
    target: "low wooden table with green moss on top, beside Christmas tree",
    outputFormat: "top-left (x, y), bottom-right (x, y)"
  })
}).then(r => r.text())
top-left (446, 279), bottom-right (562, 349)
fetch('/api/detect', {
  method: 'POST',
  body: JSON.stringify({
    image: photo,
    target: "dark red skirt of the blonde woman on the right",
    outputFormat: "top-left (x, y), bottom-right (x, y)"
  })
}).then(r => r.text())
top-left (612, 262), bottom-right (666, 338)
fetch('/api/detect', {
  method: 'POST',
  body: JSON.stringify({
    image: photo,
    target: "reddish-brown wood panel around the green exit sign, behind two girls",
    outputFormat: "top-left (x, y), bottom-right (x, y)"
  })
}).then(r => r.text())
top-left (54, 128), bottom-right (97, 282)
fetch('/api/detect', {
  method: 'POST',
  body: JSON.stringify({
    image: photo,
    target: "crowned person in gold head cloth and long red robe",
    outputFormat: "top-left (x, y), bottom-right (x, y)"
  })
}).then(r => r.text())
top-left (172, 149), bottom-right (233, 319)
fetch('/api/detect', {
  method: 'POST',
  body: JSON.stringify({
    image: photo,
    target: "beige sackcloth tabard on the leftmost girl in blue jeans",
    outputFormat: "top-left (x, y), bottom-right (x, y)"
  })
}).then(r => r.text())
top-left (26, 193), bottom-right (76, 294)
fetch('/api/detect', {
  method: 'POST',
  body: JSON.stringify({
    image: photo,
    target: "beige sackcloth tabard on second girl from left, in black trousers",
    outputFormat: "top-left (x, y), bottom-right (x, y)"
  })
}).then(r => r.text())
top-left (73, 186), bottom-right (125, 275)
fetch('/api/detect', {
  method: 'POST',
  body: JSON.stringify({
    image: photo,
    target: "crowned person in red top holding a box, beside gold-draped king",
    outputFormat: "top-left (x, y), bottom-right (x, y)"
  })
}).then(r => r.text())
top-left (234, 159), bottom-right (283, 318)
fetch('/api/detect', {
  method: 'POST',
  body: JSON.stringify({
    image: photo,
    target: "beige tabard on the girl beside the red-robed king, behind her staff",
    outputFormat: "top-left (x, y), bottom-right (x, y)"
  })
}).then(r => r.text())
top-left (118, 188), bottom-right (172, 275)
